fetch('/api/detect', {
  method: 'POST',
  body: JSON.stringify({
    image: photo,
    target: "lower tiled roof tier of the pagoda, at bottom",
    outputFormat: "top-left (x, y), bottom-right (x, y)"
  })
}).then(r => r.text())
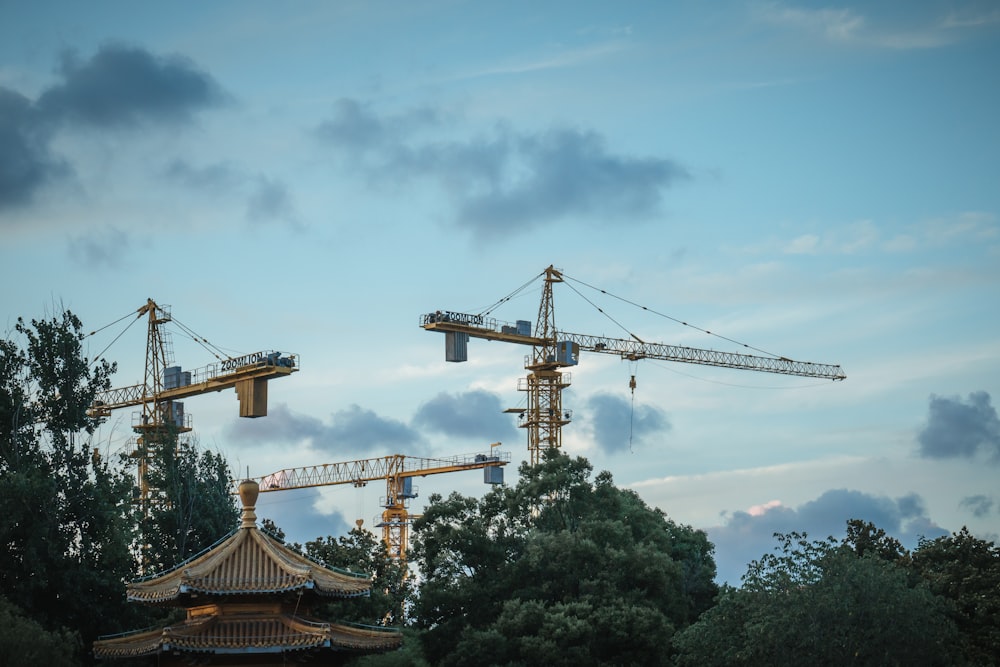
top-left (94, 612), bottom-right (402, 659)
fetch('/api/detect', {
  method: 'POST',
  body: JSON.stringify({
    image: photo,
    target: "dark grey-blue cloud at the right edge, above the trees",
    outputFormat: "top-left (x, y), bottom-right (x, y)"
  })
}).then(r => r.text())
top-left (917, 391), bottom-right (1000, 464)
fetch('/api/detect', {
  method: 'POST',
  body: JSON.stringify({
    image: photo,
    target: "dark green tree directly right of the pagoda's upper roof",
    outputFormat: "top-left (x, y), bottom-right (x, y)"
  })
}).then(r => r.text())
top-left (303, 528), bottom-right (412, 626)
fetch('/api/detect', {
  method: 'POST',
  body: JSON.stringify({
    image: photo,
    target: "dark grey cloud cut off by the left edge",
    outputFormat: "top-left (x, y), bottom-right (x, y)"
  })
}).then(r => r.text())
top-left (0, 87), bottom-right (69, 210)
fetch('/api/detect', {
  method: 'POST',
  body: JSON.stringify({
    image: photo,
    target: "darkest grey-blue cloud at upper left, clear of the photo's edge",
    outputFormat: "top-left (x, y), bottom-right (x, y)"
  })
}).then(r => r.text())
top-left (37, 44), bottom-right (225, 127)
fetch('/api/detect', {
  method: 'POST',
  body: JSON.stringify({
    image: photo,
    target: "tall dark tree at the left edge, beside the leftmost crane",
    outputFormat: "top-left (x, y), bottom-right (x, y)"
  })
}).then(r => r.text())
top-left (0, 310), bottom-right (134, 664)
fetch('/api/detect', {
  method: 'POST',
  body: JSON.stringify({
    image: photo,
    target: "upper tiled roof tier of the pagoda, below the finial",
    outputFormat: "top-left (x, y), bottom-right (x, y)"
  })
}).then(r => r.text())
top-left (126, 526), bottom-right (372, 604)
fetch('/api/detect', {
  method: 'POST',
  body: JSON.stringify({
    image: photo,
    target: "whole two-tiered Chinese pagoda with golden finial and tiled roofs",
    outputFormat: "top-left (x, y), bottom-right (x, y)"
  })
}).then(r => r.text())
top-left (94, 480), bottom-right (402, 666)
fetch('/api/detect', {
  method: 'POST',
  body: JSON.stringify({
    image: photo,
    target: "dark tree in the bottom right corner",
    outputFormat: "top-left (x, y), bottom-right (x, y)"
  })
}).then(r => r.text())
top-left (912, 527), bottom-right (1000, 665)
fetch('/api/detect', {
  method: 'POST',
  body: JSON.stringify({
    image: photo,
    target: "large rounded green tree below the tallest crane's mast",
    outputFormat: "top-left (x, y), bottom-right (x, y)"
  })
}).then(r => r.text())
top-left (412, 452), bottom-right (716, 665)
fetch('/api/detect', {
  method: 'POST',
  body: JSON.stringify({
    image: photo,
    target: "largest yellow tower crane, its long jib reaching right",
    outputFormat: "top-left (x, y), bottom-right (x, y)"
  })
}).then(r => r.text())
top-left (420, 265), bottom-right (847, 465)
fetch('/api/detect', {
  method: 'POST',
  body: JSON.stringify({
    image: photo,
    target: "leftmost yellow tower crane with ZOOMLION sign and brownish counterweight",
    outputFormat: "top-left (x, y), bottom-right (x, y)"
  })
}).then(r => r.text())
top-left (88, 299), bottom-right (299, 513)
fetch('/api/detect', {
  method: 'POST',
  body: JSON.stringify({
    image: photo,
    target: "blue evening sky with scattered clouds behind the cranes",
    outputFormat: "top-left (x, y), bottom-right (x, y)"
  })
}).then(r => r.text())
top-left (0, 1), bottom-right (1000, 583)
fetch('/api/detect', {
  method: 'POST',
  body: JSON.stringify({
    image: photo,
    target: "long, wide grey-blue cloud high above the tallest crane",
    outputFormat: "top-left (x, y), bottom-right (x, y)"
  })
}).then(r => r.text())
top-left (318, 100), bottom-right (689, 238)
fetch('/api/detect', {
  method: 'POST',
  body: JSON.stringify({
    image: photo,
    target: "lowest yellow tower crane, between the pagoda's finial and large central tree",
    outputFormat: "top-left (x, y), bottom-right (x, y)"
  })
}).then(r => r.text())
top-left (243, 442), bottom-right (510, 563)
